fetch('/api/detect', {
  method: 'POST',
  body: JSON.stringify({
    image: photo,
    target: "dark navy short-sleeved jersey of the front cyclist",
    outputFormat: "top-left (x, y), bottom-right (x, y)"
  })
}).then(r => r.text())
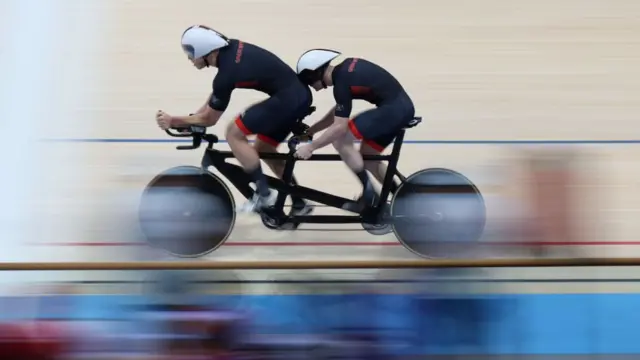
top-left (209, 39), bottom-right (300, 111)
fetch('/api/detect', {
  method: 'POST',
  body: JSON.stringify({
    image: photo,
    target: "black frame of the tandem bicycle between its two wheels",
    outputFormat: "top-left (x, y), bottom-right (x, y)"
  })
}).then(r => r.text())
top-left (201, 130), bottom-right (405, 224)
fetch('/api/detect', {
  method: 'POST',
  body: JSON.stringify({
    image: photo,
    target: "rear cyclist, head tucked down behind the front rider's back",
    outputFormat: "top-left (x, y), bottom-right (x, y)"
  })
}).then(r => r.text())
top-left (296, 49), bottom-right (415, 205)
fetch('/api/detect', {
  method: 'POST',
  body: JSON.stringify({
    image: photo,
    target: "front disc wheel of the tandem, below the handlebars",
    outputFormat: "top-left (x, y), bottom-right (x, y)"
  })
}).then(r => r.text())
top-left (139, 166), bottom-right (236, 258)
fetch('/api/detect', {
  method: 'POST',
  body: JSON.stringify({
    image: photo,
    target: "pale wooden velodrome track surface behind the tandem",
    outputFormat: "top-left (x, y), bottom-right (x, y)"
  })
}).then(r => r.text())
top-left (3, 0), bottom-right (640, 292)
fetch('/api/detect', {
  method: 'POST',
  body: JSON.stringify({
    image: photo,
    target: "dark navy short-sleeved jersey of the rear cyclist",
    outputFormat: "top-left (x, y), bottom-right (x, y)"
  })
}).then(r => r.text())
top-left (331, 58), bottom-right (405, 118)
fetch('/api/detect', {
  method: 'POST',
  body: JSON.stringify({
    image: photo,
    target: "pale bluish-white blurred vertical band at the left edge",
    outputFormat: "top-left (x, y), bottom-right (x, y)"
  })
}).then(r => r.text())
top-left (0, 0), bottom-right (106, 282)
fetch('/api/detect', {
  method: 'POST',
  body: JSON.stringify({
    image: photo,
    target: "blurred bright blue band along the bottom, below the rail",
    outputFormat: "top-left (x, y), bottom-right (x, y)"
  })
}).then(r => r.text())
top-left (0, 294), bottom-right (640, 354)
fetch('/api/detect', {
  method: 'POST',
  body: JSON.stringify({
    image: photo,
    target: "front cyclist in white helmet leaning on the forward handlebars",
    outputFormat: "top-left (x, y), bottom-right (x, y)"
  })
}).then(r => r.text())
top-left (156, 25), bottom-right (313, 215)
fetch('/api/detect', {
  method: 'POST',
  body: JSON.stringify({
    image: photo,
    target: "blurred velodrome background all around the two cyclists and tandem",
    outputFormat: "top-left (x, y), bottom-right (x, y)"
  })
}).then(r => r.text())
top-left (0, 0), bottom-right (640, 359)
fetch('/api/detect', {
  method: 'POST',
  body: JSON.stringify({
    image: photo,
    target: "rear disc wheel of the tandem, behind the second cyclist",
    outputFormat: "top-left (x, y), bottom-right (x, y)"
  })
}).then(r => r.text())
top-left (391, 168), bottom-right (486, 258)
